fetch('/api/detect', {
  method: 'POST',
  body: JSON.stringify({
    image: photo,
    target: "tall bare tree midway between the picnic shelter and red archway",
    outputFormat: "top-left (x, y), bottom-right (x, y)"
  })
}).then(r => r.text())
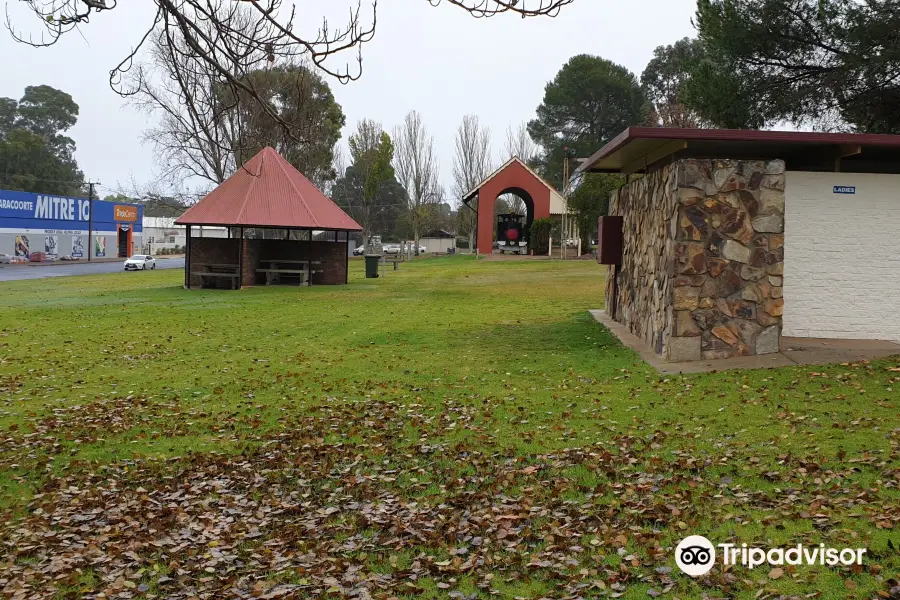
top-left (394, 111), bottom-right (443, 255)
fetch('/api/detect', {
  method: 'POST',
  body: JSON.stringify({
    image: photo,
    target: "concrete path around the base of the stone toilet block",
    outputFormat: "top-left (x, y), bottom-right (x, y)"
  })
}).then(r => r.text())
top-left (590, 310), bottom-right (900, 374)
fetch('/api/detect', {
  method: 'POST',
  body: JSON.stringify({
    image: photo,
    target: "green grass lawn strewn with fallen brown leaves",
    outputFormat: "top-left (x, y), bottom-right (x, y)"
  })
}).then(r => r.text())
top-left (0, 257), bottom-right (900, 600)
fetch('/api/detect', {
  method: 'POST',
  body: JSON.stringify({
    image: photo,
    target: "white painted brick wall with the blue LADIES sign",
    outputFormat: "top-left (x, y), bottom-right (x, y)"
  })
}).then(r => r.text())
top-left (783, 171), bottom-right (900, 341)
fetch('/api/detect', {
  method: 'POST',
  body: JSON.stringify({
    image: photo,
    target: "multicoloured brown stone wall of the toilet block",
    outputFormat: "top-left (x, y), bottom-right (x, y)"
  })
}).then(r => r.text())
top-left (607, 159), bottom-right (785, 361)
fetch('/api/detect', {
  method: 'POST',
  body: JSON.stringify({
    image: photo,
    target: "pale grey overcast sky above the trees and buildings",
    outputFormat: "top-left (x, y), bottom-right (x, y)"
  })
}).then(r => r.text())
top-left (0, 0), bottom-right (696, 202)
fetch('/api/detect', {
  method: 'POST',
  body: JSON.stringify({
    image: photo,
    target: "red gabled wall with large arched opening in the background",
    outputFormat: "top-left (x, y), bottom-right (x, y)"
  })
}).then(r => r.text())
top-left (463, 158), bottom-right (552, 254)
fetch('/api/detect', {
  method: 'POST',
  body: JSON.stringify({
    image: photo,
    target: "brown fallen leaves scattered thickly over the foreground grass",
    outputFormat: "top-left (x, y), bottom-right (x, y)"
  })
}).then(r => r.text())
top-left (0, 398), bottom-right (900, 599)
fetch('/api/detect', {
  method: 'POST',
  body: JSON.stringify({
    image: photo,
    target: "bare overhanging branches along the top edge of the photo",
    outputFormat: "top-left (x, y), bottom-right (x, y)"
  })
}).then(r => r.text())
top-left (6, 0), bottom-right (574, 128)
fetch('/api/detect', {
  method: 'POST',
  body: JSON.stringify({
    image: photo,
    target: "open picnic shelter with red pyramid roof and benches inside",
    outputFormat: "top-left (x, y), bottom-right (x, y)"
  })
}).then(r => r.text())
top-left (175, 147), bottom-right (362, 289)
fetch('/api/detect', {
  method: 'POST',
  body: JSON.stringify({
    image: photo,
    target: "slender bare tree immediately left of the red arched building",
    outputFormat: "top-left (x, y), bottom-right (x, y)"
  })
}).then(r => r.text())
top-left (453, 115), bottom-right (491, 250)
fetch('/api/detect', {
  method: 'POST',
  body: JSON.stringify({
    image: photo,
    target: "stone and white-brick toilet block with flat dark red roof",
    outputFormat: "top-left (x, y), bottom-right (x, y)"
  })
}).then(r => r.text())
top-left (579, 128), bottom-right (900, 362)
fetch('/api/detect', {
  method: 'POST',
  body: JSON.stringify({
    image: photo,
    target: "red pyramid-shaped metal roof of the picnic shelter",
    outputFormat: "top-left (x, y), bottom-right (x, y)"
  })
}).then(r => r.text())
top-left (175, 147), bottom-right (362, 231)
